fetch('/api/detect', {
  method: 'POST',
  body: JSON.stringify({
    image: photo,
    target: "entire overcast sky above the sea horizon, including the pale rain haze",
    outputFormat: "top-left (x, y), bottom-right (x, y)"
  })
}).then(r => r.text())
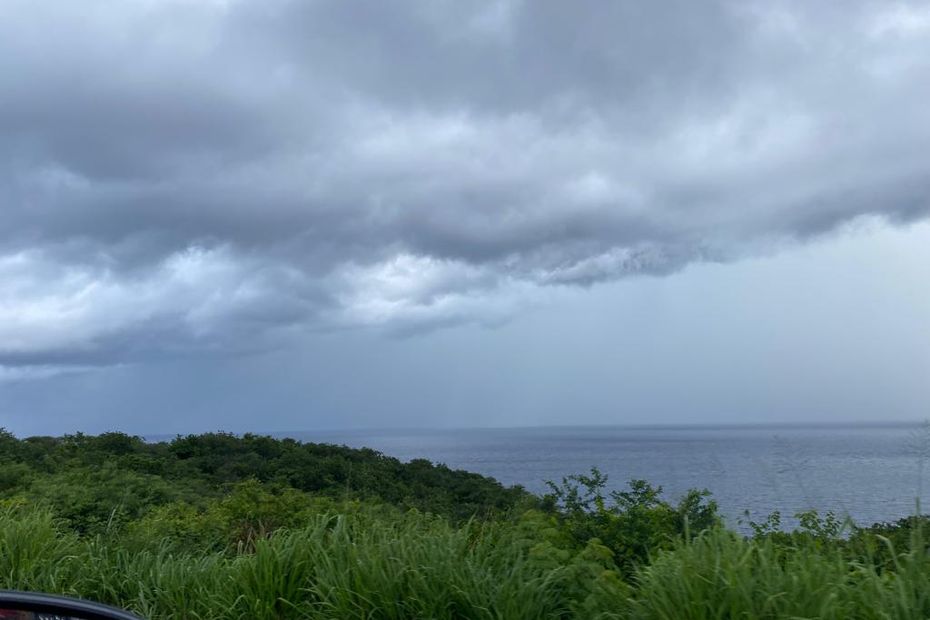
top-left (0, 0), bottom-right (930, 435)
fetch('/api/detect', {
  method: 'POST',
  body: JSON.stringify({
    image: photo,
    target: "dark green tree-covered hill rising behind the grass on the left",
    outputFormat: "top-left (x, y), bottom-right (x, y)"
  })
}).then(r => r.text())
top-left (0, 429), bottom-right (534, 533)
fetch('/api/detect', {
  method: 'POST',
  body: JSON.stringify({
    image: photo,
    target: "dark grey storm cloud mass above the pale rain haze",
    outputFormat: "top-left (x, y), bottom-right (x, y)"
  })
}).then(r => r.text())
top-left (0, 0), bottom-right (930, 367)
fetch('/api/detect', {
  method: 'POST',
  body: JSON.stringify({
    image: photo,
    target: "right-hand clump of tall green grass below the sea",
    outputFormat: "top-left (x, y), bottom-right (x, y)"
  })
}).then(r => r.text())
top-left (630, 530), bottom-right (930, 620)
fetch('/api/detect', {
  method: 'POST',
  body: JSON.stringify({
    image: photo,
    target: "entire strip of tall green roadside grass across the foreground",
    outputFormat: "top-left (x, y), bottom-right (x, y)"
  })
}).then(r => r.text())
top-left (0, 506), bottom-right (930, 620)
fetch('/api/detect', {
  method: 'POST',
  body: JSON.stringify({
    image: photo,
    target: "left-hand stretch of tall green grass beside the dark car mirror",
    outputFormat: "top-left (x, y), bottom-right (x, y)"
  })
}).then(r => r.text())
top-left (0, 509), bottom-right (584, 620)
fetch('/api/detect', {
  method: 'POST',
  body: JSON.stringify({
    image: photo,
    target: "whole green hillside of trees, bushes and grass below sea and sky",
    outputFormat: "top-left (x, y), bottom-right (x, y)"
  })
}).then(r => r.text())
top-left (0, 431), bottom-right (930, 619)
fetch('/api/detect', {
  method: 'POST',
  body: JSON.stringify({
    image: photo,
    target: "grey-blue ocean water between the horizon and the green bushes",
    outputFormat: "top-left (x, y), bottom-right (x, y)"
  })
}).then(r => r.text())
top-left (280, 425), bottom-right (930, 529)
